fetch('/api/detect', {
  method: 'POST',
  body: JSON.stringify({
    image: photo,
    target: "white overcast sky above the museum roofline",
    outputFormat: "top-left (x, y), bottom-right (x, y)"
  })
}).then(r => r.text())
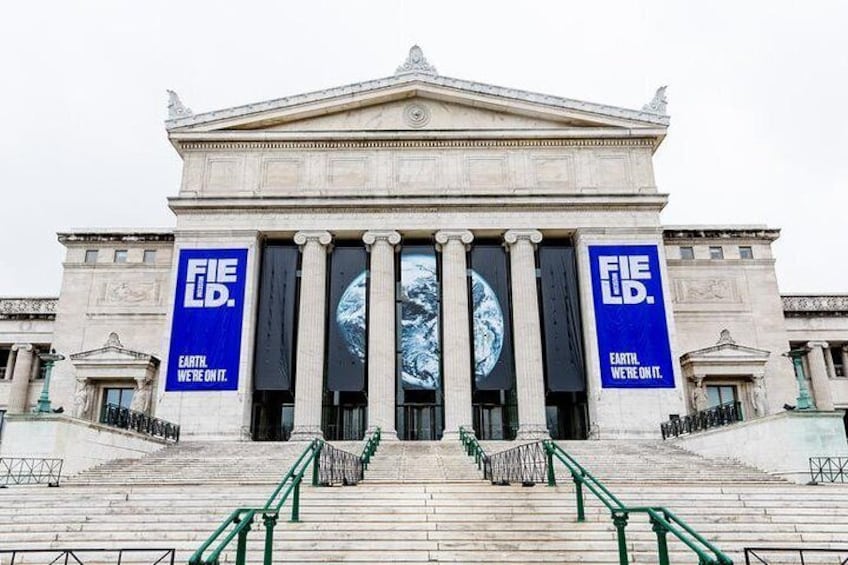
top-left (0, 0), bottom-right (848, 296)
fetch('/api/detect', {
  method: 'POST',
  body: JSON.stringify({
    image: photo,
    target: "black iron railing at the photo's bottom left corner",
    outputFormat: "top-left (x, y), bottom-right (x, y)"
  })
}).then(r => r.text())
top-left (0, 548), bottom-right (175, 565)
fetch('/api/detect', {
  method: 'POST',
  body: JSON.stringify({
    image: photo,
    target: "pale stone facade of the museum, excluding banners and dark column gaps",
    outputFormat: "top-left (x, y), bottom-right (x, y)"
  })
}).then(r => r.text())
top-left (0, 48), bottom-right (848, 439)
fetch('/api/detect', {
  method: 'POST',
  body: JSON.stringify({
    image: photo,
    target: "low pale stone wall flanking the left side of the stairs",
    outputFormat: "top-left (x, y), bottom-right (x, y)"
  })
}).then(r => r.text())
top-left (0, 414), bottom-right (167, 477)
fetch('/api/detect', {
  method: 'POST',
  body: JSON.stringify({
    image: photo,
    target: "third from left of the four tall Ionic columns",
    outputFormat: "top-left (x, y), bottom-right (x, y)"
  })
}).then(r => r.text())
top-left (436, 230), bottom-right (474, 440)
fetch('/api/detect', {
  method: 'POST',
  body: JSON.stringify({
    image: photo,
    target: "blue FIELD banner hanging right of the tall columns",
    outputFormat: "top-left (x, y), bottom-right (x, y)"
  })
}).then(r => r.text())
top-left (589, 245), bottom-right (674, 388)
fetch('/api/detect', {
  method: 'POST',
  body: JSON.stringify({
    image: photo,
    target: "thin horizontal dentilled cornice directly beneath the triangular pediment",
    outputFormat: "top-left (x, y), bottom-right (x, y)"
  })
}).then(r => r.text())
top-left (173, 134), bottom-right (655, 148)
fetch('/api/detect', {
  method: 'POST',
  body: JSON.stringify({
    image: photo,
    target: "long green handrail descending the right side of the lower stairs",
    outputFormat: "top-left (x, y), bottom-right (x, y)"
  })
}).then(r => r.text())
top-left (543, 441), bottom-right (733, 565)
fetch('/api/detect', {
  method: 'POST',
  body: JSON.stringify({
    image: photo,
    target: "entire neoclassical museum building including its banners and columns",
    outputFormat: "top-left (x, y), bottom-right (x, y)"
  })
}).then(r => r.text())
top-left (0, 47), bottom-right (848, 446)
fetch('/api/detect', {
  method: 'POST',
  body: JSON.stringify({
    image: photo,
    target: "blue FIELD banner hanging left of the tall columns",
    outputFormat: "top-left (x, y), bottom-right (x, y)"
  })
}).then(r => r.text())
top-left (165, 249), bottom-right (247, 391)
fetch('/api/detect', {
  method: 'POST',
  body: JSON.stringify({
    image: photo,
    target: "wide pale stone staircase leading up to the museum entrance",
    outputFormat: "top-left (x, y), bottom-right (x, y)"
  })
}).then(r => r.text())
top-left (0, 441), bottom-right (848, 565)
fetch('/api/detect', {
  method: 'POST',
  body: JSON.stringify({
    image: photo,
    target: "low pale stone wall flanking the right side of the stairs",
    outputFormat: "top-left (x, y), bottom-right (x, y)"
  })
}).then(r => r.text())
top-left (673, 411), bottom-right (848, 484)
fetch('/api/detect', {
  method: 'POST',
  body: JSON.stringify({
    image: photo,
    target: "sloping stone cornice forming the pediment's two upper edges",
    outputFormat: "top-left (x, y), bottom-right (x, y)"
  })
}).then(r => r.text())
top-left (165, 72), bottom-right (669, 131)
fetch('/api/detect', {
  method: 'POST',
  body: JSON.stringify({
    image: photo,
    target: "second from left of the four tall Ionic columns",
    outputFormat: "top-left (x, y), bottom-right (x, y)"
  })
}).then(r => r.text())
top-left (362, 227), bottom-right (400, 439)
